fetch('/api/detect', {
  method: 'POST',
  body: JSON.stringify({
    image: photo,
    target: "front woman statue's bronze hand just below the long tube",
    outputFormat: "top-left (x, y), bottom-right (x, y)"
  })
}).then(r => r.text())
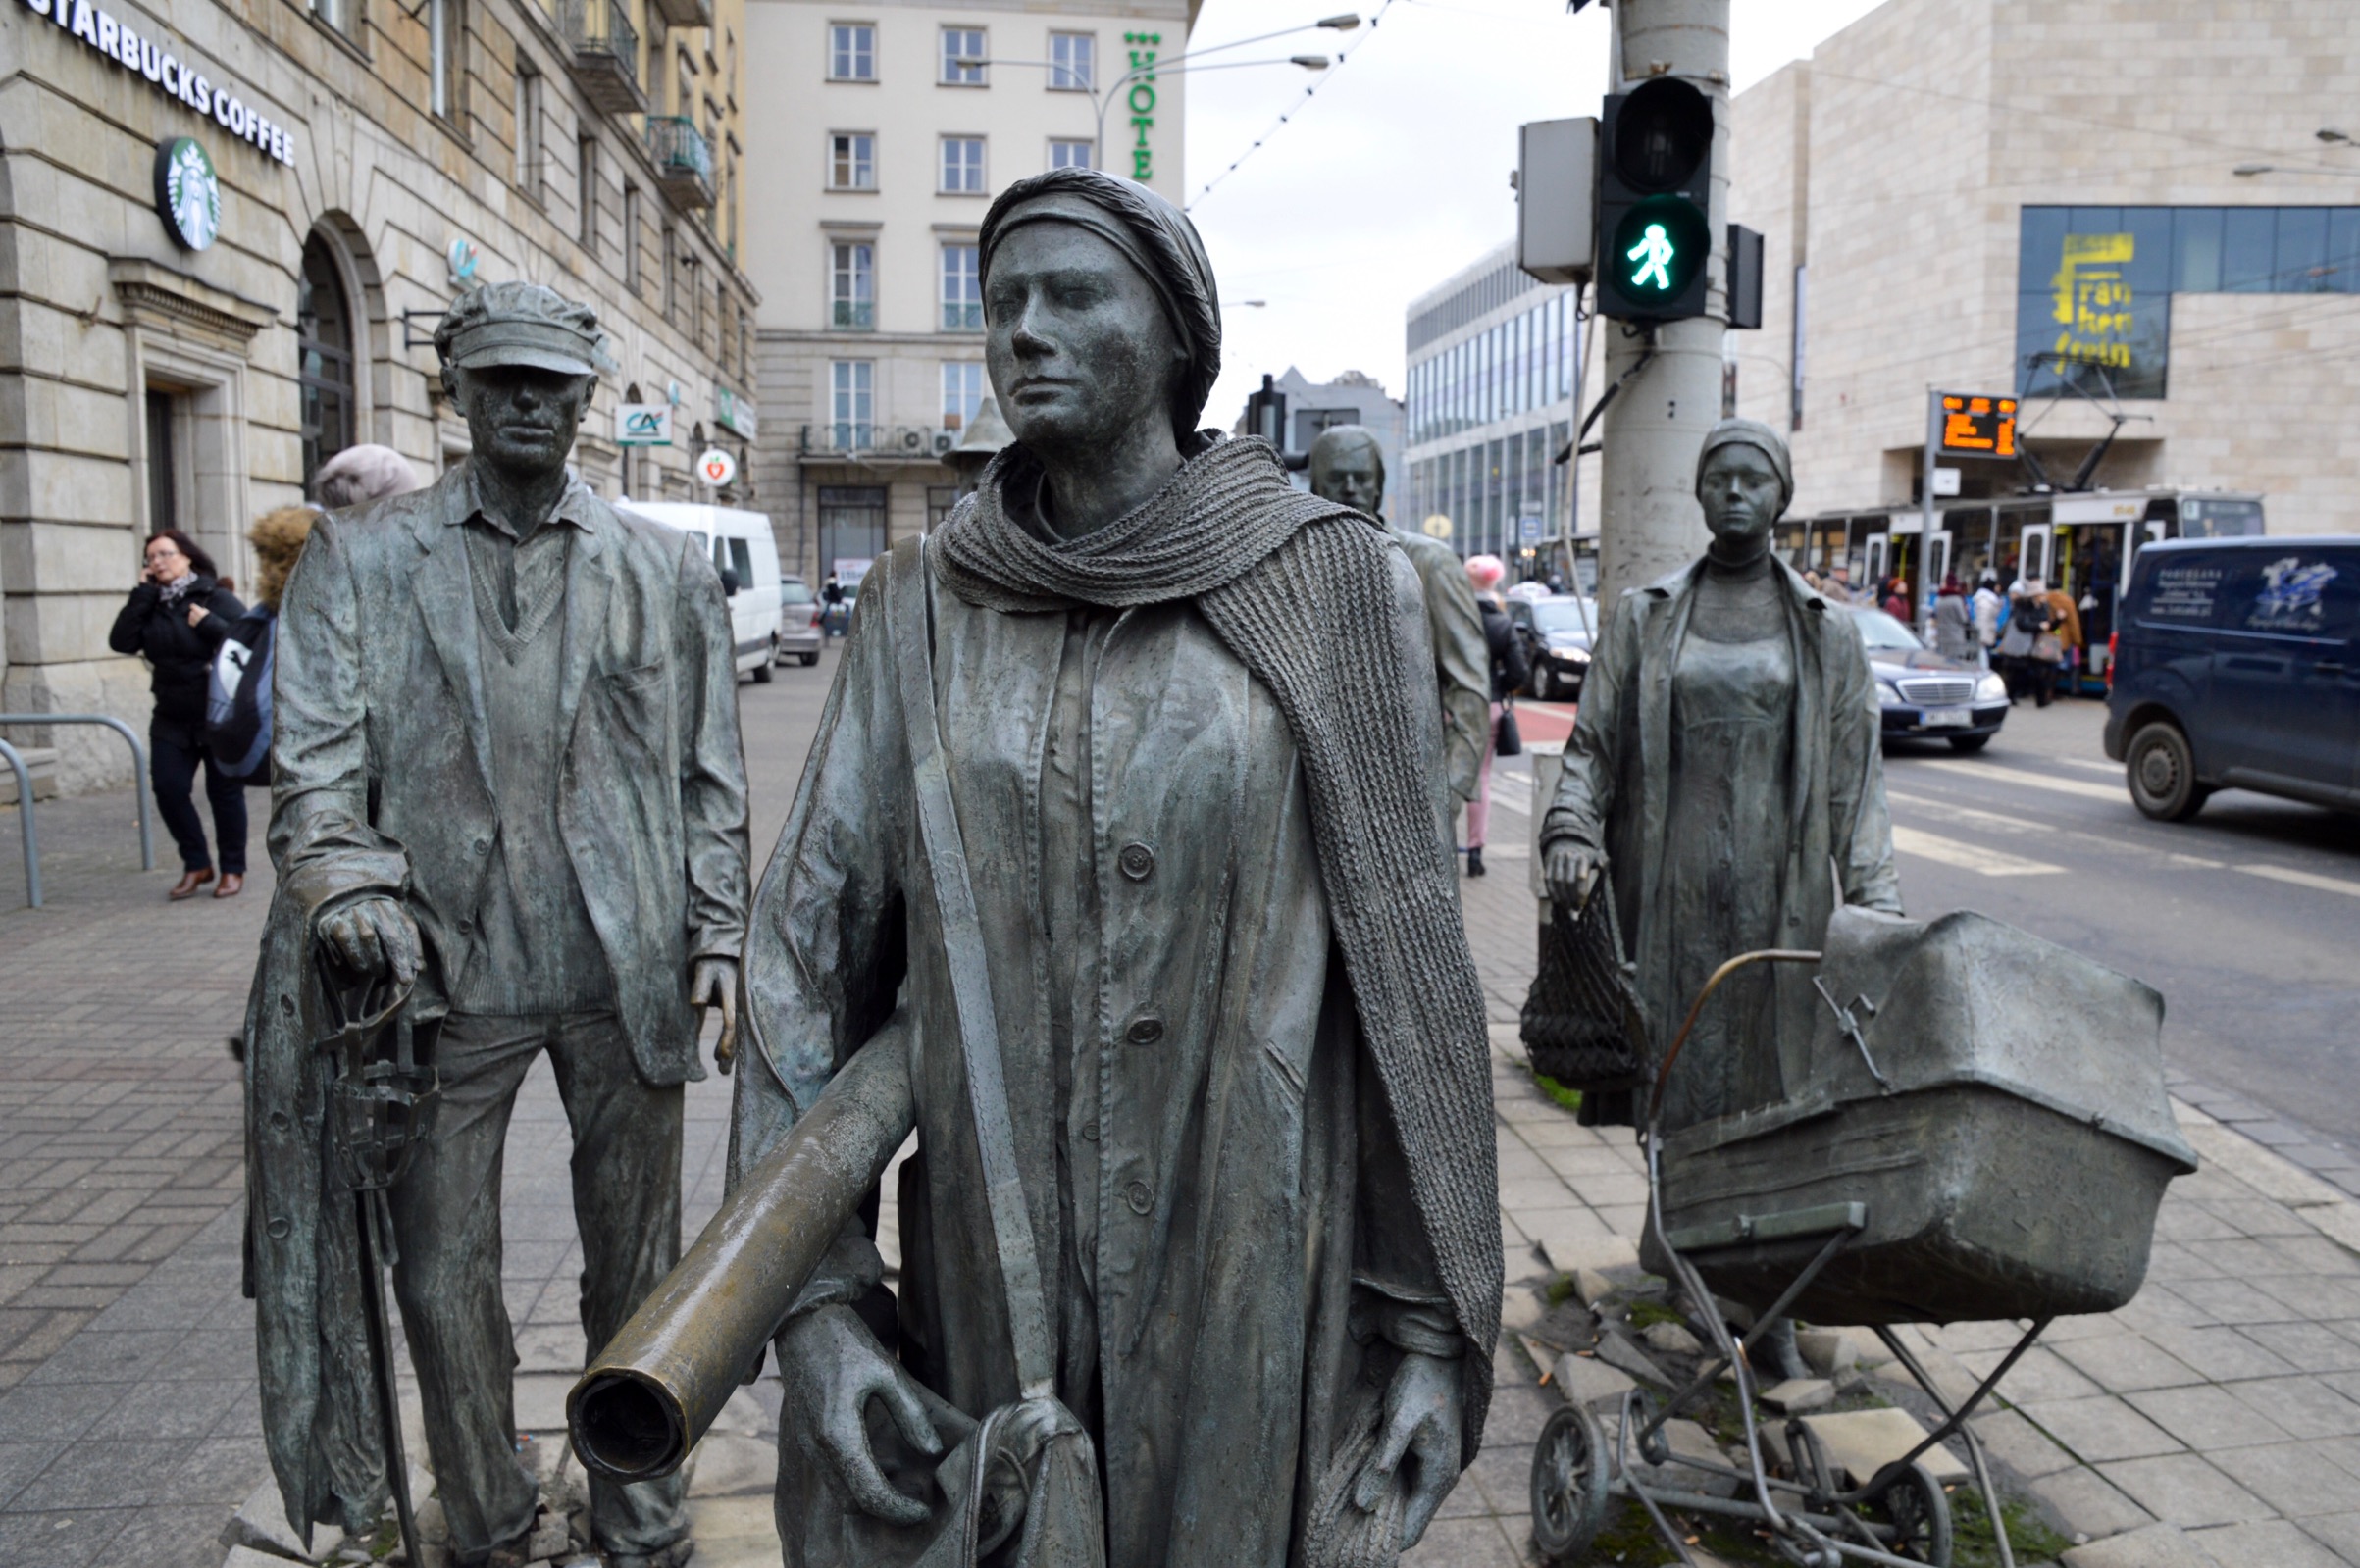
top-left (779, 1306), bottom-right (942, 1526)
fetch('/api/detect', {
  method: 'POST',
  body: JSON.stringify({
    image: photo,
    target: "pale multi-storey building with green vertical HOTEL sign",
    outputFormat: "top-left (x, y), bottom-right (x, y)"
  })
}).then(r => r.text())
top-left (745, 0), bottom-right (1199, 582)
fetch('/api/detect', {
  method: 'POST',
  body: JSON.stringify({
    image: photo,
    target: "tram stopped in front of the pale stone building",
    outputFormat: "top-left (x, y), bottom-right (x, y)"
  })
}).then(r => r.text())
top-left (1777, 488), bottom-right (2263, 679)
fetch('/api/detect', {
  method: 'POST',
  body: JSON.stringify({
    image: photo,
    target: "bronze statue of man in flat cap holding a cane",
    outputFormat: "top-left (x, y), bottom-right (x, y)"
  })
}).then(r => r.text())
top-left (248, 283), bottom-right (748, 1568)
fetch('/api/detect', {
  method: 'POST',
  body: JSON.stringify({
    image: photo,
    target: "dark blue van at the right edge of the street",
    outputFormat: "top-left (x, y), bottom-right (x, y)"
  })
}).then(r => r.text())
top-left (2105, 537), bottom-right (2360, 823)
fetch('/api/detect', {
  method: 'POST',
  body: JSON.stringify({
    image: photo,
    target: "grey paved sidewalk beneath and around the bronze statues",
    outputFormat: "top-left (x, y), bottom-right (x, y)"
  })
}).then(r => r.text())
top-left (14, 655), bottom-right (2360, 1568)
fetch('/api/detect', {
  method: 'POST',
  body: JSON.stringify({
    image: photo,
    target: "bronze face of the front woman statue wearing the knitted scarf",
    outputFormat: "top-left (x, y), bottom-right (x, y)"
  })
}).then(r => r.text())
top-left (984, 222), bottom-right (1185, 460)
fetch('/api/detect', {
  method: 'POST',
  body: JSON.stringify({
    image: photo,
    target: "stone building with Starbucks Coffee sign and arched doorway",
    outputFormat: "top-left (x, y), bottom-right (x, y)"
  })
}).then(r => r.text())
top-left (0, 0), bottom-right (757, 790)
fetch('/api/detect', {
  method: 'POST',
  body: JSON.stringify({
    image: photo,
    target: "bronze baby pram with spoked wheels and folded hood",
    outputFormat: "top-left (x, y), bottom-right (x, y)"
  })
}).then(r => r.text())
top-left (1531, 901), bottom-right (2195, 1568)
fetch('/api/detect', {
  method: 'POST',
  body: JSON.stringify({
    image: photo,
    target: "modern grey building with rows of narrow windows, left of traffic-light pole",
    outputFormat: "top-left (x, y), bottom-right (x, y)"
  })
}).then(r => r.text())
top-left (1400, 243), bottom-right (1595, 576)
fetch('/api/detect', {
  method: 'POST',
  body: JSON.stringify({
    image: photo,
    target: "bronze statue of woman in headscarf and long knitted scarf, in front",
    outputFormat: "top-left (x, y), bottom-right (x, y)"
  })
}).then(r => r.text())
top-left (732, 170), bottom-right (1501, 1568)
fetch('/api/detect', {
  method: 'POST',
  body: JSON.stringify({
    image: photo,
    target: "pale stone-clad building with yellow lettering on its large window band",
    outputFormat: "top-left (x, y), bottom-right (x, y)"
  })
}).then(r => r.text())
top-left (1730, 0), bottom-right (2360, 532)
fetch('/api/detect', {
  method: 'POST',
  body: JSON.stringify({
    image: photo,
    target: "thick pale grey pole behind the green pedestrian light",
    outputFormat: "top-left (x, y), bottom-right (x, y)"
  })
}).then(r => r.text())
top-left (1593, 0), bottom-right (1730, 608)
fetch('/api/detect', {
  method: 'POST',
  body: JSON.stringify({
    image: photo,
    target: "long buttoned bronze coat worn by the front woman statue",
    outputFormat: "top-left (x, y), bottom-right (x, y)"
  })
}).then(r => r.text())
top-left (732, 552), bottom-right (1489, 1568)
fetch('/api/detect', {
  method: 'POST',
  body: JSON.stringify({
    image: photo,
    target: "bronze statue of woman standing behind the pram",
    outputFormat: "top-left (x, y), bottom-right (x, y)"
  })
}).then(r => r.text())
top-left (1541, 420), bottom-right (1900, 1132)
